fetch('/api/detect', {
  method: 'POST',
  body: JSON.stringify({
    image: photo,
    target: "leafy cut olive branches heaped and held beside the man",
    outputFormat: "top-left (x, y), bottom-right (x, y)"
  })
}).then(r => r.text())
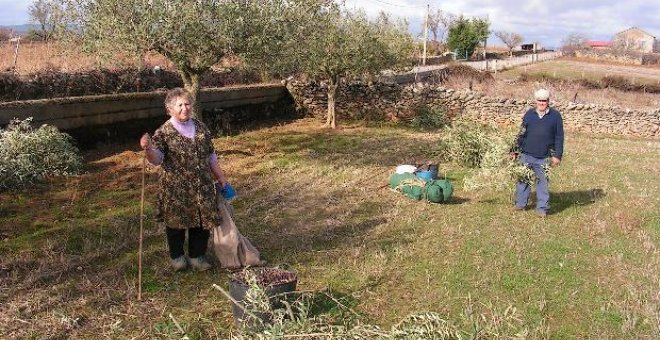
top-left (441, 120), bottom-right (549, 191)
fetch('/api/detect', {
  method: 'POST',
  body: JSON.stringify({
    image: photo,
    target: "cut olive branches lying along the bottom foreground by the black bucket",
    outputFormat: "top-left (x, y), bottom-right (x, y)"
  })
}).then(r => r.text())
top-left (213, 270), bottom-right (529, 340)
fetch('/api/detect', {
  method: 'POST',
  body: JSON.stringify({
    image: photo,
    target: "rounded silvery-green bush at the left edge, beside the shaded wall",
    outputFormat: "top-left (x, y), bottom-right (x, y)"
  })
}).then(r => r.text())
top-left (0, 119), bottom-right (83, 190)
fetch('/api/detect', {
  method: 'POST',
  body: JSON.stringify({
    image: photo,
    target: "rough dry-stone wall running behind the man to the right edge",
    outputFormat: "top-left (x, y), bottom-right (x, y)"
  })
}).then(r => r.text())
top-left (287, 82), bottom-right (660, 138)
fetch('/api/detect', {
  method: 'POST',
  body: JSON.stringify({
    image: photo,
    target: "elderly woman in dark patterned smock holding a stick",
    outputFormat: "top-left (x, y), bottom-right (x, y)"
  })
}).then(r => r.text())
top-left (140, 88), bottom-right (227, 271)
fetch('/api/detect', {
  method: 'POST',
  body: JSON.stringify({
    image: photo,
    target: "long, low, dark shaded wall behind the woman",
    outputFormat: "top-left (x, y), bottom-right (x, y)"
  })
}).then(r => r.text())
top-left (0, 84), bottom-right (297, 148)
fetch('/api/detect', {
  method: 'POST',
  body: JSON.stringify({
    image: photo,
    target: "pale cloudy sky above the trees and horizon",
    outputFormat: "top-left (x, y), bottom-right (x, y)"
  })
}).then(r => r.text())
top-left (0, 0), bottom-right (660, 47)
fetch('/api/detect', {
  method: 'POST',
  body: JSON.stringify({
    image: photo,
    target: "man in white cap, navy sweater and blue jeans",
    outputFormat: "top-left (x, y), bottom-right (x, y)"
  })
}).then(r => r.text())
top-left (511, 89), bottom-right (564, 217)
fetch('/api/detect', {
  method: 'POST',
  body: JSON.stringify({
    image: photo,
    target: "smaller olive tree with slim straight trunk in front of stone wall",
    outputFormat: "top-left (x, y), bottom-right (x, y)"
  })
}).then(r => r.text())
top-left (282, 3), bottom-right (413, 129)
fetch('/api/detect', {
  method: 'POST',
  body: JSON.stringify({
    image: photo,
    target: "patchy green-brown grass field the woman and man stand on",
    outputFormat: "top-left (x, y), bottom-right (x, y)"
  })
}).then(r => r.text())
top-left (0, 120), bottom-right (660, 339)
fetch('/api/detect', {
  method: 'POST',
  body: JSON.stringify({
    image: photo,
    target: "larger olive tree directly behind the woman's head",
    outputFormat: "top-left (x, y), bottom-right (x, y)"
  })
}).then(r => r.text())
top-left (60, 0), bottom-right (268, 119)
